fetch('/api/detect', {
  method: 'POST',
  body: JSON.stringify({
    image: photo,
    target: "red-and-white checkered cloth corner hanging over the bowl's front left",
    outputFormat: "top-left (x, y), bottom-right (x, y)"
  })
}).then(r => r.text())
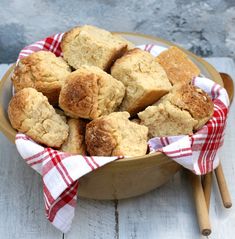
top-left (16, 134), bottom-right (120, 232)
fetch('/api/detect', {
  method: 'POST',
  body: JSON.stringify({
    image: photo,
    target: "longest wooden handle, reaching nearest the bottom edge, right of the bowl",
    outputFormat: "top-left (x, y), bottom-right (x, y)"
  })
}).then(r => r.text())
top-left (190, 173), bottom-right (211, 236)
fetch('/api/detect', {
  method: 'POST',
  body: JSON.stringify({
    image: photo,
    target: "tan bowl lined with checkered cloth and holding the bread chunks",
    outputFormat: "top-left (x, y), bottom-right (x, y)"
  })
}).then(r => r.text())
top-left (0, 32), bottom-right (223, 200)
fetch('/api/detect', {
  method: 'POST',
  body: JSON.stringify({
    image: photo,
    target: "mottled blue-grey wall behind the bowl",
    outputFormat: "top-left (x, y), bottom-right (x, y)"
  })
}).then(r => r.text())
top-left (0, 0), bottom-right (235, 63)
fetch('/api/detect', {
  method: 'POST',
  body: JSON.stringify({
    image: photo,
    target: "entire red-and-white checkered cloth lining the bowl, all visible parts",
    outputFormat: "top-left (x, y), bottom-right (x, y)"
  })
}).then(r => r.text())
top-left (16, 33), bottom-right (229, 232)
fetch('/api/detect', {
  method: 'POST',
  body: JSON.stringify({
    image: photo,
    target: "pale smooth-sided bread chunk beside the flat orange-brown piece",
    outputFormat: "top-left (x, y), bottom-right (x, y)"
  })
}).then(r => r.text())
top-left (111, 48), bottom-right (172, 115)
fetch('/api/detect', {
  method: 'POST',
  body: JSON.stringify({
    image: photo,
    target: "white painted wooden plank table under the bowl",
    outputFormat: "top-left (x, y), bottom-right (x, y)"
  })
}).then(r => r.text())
top-left (0, 58), bottom-right (235, 239)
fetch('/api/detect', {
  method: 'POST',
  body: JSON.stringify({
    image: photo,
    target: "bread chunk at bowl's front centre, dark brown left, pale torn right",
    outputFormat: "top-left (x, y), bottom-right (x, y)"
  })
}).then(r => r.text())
top-left (86, 112), bottom-right (148, 156)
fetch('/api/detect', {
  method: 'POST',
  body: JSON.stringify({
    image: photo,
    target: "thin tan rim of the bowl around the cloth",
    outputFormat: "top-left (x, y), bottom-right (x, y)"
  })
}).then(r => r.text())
top-left (0, 32), bottom-right (223, 167)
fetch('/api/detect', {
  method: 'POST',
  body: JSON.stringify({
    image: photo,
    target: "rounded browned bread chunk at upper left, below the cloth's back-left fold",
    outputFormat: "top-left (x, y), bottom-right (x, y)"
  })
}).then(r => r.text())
top-left (11, 51), bottom-right (71, 105)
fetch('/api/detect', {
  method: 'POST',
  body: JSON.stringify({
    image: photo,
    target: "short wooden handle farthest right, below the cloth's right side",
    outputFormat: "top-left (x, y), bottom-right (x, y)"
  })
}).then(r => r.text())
top-left (215, 163), bottom-right (232, 208)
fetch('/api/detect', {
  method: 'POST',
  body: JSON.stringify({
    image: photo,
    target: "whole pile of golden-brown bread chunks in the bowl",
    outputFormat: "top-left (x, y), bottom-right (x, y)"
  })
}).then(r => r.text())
top-left (8, 25), bottom-right (213, 156)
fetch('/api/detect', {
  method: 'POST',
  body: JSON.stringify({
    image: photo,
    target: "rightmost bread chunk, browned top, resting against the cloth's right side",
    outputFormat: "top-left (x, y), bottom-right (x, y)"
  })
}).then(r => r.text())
top-left (138, 84), bottom-right (214, 137)
